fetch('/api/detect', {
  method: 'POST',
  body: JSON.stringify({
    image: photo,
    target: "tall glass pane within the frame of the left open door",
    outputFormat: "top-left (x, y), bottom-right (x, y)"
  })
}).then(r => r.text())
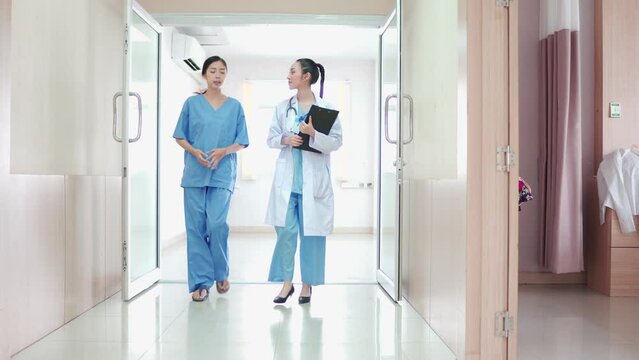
top-left (129, 13), bottom-right (159, 281)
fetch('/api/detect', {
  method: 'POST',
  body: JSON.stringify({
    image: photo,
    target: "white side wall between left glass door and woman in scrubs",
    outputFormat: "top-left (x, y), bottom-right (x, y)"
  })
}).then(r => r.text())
top-left (159, 27), bottom-right (199, 245)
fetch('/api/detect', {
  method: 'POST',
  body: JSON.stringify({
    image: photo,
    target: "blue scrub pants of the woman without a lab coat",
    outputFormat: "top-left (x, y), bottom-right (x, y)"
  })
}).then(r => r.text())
top-left (184, 187), bottom-right (231, 292)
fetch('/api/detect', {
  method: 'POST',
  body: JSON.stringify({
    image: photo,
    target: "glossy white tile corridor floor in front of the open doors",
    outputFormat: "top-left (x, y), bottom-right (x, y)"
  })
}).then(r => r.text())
top-left (13, 283), bottom-right (454, 360)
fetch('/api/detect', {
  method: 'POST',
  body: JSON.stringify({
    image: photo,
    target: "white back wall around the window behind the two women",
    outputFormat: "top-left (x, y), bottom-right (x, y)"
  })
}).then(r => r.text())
top-left (227, 58), bottom-right (376, 228)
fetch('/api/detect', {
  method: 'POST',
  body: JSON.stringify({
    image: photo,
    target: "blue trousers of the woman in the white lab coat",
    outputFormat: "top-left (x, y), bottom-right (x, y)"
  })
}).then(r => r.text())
top-left (268, 193), bottom-right (326, 285)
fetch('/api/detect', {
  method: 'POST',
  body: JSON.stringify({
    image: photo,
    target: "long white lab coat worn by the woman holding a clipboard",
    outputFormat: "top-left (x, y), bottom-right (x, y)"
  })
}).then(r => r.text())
top-left (266, 95), bottom-right (342, 236)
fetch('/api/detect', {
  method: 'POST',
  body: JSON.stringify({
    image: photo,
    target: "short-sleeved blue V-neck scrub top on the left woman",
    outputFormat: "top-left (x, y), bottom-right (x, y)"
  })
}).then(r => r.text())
top-left (173, 95), bottom-right (249, 192)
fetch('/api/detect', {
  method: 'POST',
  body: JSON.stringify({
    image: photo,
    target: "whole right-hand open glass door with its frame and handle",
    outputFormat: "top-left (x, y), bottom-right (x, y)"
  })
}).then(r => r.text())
top-left (377, 11), bottom-right (401, 301)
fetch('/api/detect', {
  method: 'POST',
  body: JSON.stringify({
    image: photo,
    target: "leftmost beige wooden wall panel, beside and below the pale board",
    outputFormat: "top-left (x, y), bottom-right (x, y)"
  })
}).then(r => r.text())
top-left (0, 0), bottom-right (64, 355)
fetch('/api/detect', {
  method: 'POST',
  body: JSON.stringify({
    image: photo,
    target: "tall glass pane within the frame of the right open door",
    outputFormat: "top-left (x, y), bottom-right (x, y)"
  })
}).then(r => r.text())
top-left (379, 17), bottom-right (399, 282)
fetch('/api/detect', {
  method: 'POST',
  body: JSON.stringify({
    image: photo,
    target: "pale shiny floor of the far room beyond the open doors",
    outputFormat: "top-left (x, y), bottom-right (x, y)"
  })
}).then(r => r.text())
top-left (162, 232), bottom-right (377, 284)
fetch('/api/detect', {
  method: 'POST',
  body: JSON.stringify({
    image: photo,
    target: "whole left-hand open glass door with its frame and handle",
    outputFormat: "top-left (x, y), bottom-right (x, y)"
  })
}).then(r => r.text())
top-left (114, 0), bottom-right (161, 300)
